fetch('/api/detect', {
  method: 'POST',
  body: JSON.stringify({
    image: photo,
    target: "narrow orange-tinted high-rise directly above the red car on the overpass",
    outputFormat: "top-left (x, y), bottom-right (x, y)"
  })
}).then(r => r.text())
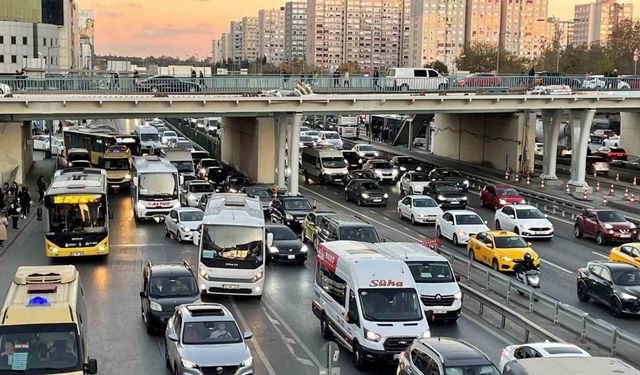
top-left (465, 0), bottom-right (502, 48)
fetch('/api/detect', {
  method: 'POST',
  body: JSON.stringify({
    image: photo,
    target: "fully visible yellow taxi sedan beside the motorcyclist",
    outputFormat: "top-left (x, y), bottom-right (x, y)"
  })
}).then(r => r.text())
top-left (467, 230), bottom-right (540, 272)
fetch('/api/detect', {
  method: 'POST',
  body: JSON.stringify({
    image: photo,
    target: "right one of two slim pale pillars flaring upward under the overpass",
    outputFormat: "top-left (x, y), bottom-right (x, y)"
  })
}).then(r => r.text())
top-left (568, 109), bottom-right (596, 187)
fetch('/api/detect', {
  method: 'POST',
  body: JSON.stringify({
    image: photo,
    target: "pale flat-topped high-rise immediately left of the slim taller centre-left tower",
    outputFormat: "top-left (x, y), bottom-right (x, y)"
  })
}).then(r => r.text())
top-left (258, 7), bottom-right (285, 65)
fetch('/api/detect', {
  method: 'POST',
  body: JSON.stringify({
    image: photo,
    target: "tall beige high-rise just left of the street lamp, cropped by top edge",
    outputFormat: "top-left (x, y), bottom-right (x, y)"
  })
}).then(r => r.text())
top-left (500, 0), bottom-right (548, 59)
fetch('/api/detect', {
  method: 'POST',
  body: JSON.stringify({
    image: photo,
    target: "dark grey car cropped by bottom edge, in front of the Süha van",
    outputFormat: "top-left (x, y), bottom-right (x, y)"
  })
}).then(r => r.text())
top-left (397, 337), bottom-right (500, 375)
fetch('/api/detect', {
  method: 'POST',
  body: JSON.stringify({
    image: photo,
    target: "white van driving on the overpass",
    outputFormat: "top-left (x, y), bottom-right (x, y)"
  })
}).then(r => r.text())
top-left (385, 68), bottom-right (449, 91)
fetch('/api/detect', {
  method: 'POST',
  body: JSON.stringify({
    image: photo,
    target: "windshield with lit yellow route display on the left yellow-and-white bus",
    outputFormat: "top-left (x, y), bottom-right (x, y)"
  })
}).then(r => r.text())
top-left (48, 194), bottom-right (107, 233)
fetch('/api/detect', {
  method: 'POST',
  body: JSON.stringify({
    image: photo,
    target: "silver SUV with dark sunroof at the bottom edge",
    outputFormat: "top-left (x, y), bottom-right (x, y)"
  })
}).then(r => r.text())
top-left (164, 302), bottom-right (253, 375)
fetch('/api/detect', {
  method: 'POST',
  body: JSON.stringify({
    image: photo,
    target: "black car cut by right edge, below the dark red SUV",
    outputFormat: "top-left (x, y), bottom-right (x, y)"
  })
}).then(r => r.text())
top-left (578, 261), bottom-right (640, 318)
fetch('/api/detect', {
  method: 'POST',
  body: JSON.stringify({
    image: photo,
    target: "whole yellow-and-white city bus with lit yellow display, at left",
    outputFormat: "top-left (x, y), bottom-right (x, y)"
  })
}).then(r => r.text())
top-left (43, 168), bottom-right (110, 257)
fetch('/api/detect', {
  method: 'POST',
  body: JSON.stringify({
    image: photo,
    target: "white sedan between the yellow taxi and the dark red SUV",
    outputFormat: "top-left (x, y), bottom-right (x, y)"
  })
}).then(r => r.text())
top-left (494, 204), bottom-right (554, 238)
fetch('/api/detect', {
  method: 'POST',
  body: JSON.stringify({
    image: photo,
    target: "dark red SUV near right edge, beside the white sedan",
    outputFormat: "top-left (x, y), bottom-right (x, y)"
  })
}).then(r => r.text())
top-left (573, 209), bottom-right (638, 245)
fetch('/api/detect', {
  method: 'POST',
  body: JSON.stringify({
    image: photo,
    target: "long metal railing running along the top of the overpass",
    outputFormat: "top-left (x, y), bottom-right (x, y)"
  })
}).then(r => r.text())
top-left (0, 75), bottom-right (640, 95)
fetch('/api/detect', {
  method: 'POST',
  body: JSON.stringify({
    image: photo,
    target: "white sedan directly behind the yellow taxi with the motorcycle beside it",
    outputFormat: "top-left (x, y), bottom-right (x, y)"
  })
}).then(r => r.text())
top-left (436, 210), bottom-right (491, 246)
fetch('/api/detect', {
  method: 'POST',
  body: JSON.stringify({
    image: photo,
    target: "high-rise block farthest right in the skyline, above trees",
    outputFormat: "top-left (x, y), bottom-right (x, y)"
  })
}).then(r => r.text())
top-left (573, 0), bottom-right (633, 45)
